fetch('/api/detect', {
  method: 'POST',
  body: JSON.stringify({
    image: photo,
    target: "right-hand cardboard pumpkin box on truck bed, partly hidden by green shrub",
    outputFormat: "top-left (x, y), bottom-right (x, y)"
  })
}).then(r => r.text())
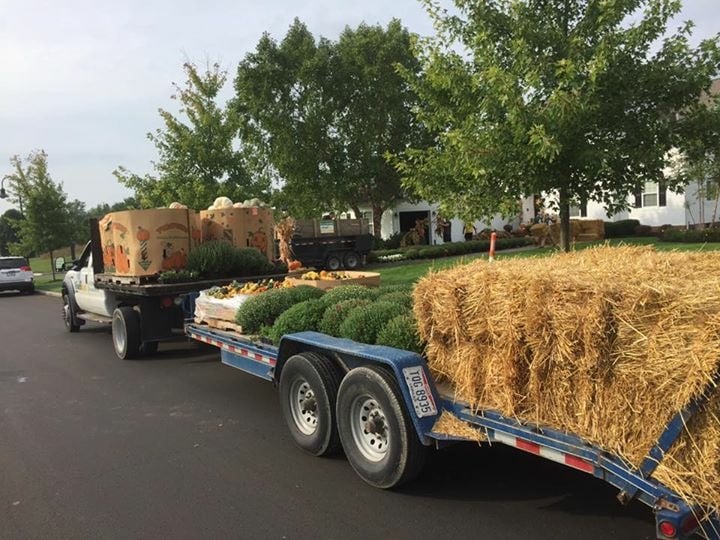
top-left (200, 207), bottom-right (275, 261)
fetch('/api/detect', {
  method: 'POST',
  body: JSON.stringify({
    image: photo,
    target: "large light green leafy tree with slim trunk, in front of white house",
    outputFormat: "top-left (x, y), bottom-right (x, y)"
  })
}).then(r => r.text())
top-left (396, 0), bottom-right (720, 250)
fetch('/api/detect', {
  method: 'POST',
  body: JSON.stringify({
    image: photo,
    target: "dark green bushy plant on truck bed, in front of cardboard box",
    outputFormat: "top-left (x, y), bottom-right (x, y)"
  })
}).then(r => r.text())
top-left (186, 241), bottom-right (275, 279)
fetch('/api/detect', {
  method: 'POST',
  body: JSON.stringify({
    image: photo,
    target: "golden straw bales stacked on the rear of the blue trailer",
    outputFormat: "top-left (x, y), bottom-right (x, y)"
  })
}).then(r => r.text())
top-left (414, 247), bottom-right (720, 508)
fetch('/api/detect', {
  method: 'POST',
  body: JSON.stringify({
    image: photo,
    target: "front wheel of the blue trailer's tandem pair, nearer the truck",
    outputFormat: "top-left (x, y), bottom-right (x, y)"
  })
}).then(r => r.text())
top-left (280, 352), bottom-right (341, 456)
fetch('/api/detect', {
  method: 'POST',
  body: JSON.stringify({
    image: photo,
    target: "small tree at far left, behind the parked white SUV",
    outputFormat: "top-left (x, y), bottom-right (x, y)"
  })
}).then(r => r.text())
top-left (10, 150), bottom-right (72, 280)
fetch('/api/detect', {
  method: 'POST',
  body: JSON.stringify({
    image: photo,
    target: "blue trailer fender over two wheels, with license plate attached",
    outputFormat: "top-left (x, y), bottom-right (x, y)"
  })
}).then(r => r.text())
top-left (273, 332), bottom-right (440, 446)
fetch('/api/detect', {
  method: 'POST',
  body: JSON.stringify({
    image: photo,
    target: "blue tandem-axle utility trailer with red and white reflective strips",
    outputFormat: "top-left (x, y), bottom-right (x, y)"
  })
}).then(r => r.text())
top-left (186, 323), bottom-right (720, 540)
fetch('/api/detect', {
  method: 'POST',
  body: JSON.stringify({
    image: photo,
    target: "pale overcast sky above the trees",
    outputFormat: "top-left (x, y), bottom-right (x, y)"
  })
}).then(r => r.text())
top-left (0, 0), bottom-right (720, 213)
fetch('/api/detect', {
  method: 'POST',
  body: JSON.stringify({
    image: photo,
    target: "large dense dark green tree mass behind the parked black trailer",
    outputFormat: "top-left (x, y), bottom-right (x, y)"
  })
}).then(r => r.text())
top-left (234, 19), bottom-right (427, 236)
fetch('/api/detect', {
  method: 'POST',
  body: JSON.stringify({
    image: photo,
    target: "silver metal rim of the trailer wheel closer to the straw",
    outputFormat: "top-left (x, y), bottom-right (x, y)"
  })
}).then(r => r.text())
top-left (350, 395), bottom-right (390, 462)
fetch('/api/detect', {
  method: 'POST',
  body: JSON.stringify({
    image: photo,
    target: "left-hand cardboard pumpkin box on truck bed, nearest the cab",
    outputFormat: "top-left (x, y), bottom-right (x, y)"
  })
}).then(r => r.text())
top-left (99, 208), bottom-right (192, 276)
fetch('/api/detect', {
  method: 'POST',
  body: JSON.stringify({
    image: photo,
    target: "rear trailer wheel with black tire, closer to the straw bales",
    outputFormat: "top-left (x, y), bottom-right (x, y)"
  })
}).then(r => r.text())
top-left (337, 366), bottom-right (427, 489)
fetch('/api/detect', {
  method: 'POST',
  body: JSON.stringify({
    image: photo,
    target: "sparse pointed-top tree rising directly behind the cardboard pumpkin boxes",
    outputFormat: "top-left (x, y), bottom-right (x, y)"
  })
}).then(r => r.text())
top-left (113, 63), bottom-right (269, 209)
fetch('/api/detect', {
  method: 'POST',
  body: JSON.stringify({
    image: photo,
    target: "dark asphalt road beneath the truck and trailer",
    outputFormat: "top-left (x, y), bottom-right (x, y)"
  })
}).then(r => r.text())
top-left (0, 295), bottom-right (654, 540)
